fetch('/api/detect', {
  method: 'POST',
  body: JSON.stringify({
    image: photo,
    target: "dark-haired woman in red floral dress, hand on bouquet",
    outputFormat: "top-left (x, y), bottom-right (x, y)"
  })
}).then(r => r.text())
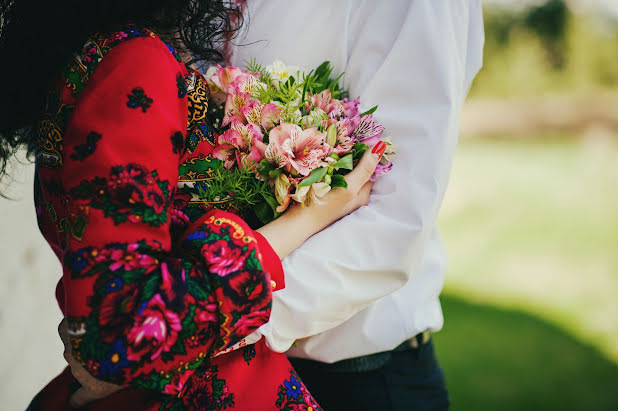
top-left (0, 0), bottom-right (381, 410)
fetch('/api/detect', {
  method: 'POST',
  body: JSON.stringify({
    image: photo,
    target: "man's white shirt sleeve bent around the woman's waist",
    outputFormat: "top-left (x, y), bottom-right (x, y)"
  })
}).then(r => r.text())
top-left (260, 0), bottom-right (483, 351)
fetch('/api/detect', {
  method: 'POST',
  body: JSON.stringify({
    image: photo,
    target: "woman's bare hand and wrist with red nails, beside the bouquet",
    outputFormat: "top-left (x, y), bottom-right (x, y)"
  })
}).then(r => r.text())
top-left (257, 141), bottom-right (386, 260)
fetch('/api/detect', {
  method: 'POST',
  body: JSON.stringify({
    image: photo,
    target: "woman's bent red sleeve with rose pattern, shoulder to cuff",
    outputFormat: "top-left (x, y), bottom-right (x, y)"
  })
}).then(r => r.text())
top-left (61, 38), bottom-right (272, 395)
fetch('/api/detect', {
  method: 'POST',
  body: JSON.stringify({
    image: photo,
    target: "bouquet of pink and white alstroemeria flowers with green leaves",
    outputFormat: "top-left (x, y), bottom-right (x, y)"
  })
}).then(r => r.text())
top-left (197, 60), bottom-right (394, 224)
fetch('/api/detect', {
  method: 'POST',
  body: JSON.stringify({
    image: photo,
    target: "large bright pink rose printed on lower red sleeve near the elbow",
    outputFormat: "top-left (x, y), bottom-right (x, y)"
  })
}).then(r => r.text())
top-left (127, 294), bottom-right (182, 361)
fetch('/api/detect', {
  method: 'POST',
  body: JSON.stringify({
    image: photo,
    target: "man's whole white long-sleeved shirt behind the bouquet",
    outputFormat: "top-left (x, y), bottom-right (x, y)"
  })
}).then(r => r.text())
top-left (231, 0), bottom-right (484, 362)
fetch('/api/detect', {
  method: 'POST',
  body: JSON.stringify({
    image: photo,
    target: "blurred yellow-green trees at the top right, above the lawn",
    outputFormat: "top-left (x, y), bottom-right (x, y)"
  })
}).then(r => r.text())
top-left (470, 0), bottom-right (618, 97)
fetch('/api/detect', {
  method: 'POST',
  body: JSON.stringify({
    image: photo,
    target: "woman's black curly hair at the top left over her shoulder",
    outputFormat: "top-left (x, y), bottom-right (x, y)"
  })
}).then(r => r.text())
top-left (0, 0), bottom-right (242, 190)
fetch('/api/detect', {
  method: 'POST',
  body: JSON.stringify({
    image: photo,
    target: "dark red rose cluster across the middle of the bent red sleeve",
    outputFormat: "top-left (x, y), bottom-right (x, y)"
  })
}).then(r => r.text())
top-left (70, 164), bottom-right (171, 227)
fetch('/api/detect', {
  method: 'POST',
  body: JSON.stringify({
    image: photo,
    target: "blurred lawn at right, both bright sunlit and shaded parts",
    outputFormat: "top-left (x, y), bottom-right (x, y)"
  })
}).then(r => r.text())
top-left (436, 138), bottom-right (618, 410)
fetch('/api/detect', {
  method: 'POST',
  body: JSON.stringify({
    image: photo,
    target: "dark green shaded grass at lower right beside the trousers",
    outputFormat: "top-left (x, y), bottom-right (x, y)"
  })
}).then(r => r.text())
top-left (435, 296), bottom-right (618, 411)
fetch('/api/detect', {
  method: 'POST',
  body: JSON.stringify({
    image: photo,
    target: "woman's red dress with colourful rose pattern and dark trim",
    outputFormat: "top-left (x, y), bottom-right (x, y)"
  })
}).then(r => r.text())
top-left (30, 26), bottom-right (319, 411)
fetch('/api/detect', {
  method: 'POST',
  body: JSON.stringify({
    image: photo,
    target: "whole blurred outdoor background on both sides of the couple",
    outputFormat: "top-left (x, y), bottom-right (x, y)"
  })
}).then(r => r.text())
top-left (0, 0), bottom-right (618, 411)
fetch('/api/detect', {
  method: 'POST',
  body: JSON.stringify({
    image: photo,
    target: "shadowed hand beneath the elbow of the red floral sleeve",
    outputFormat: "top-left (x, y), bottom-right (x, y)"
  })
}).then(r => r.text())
top-left (58, 319), bottom-right (124, 408)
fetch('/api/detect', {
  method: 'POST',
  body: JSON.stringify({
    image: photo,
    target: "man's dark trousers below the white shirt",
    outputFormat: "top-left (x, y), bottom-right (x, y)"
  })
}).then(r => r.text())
top-left (290, 340), bottom-right (449, 411)
